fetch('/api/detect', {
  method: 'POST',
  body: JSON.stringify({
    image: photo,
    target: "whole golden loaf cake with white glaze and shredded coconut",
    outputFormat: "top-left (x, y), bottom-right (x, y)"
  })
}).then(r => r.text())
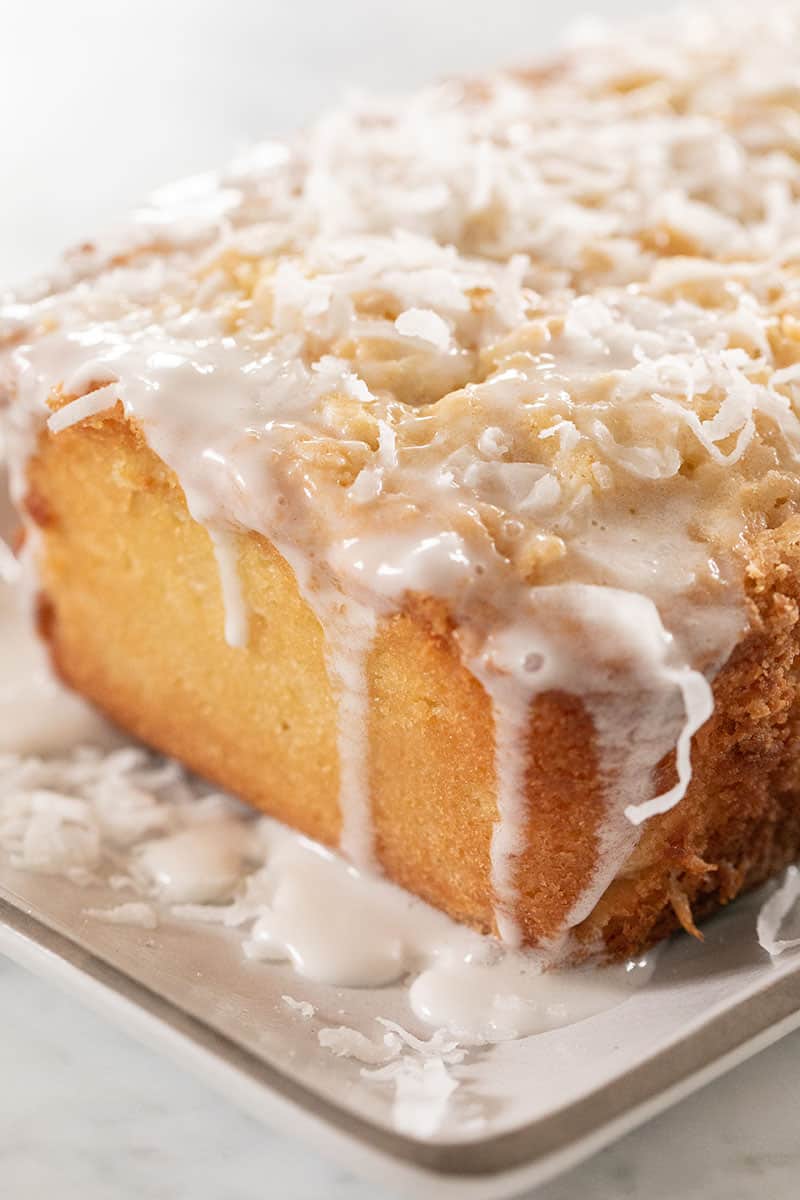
top-left (0, 4), bottom-right (800, 958)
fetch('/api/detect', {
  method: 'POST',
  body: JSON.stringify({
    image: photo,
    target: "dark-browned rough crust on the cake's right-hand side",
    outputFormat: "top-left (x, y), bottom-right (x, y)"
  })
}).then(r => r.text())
top-left (576, 517), bottom-right (800, 953)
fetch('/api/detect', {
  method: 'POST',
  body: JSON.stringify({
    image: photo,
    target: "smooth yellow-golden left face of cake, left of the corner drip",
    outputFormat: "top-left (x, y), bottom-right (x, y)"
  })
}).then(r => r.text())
top-left (28, 421), bottom-right (494, 928)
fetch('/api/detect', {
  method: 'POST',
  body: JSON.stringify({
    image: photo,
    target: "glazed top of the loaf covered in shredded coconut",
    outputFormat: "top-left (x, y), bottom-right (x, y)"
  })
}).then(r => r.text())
top-left (0, 2), bottom-right (800, 936)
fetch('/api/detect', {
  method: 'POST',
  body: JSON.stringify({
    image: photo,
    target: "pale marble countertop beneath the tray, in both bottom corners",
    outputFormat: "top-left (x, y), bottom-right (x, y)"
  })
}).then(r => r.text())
top-left (0, 959), bottom-right (800, 1200)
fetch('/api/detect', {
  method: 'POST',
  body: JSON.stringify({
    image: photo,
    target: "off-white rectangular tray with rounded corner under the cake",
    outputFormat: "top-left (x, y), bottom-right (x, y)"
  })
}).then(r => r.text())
top-left (0, 849), bottom-right (800, 1198)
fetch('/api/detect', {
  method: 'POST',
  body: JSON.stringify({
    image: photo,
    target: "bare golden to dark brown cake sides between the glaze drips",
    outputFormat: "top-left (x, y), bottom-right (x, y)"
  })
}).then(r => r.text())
top-left (28, 413), bottom-right (800, 955)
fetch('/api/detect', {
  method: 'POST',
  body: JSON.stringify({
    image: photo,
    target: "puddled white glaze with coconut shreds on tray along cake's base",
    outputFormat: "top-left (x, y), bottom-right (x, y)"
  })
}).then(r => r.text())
top-left (0, 561), bottom-right (649, 1041)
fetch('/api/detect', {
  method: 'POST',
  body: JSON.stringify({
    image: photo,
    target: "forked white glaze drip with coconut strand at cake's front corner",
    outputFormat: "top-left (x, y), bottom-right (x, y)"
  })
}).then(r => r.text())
top-left (473, 584), bottom-right (740, 944)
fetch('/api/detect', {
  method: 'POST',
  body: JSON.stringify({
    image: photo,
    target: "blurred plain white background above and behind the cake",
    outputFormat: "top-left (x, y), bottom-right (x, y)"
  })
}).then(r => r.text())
top-left (0, 0), bottom-right (663, 282)
